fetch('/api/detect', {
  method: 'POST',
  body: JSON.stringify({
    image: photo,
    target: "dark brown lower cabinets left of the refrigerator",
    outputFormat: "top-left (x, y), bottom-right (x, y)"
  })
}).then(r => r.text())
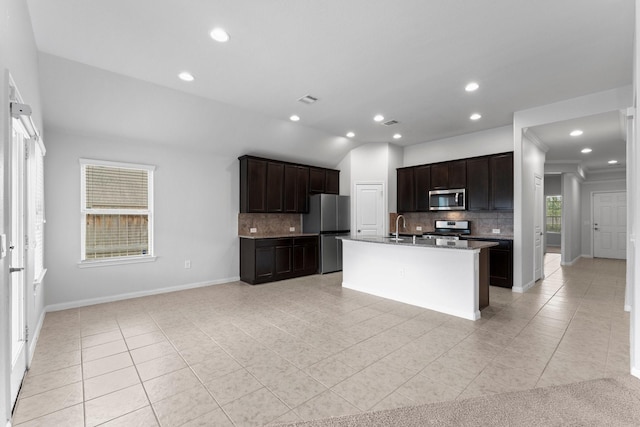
top-left (240, 236), bottom-right (318, 285)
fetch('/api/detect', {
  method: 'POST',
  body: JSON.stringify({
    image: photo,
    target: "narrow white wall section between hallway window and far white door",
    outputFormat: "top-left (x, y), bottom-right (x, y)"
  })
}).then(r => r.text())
top-left (561, 173), bottom-right (583, 265)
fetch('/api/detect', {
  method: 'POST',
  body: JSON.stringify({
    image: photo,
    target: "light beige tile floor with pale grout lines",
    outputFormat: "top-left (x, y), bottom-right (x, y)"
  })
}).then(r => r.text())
top-left (13, 254), bottom-right (629, 427)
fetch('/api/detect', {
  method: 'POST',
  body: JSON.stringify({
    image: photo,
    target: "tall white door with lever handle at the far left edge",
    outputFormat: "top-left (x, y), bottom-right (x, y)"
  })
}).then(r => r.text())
top-left (9, 119), bottom-right (29, 404)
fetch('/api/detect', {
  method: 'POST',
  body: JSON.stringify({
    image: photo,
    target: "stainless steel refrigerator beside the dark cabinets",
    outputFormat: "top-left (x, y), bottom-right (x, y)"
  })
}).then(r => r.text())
top-left (302, 194), bottom-right (351, 273)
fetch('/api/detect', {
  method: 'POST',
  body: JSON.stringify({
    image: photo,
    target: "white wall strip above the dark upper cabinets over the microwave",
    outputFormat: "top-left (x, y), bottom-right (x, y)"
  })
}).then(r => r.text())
top-left (403, 126), bottom-right (513, 166)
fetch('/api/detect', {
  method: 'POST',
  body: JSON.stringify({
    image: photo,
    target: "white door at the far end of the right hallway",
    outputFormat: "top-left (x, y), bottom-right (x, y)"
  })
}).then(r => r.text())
top-left (592, 191), bottom-right (627, 259)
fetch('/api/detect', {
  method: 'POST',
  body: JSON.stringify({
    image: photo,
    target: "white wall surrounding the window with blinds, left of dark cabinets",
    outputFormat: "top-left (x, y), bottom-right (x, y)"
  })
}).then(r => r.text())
top-left (45, 130), bottom-right (239, 309)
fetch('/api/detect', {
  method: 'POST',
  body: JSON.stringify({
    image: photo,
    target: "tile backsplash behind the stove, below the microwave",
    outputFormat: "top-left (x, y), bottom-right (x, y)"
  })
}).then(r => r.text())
top-left (389, 211), bottom-right (513, 237)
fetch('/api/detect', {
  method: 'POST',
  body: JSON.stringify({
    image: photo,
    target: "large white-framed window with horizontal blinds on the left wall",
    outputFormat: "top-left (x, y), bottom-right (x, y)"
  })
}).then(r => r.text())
top-left (80, 159), bottom-right (154, 264)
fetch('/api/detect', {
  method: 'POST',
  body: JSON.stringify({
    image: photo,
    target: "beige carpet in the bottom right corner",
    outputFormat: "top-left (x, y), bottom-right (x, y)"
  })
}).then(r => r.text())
top-left (283, 375), bottom-right (640, 427)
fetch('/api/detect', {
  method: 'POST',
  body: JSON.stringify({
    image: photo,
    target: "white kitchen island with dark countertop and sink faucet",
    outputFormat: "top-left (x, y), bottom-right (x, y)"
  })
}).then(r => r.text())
top-left (342, 237), bottom-right (497, 320)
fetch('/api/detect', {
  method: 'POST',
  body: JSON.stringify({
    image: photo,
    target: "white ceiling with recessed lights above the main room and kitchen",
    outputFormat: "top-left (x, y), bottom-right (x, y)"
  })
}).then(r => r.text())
top-left (28, 0), bottom-right (635, 169)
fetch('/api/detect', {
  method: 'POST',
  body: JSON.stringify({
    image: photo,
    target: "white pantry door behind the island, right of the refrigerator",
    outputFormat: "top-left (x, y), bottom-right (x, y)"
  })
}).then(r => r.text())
top-left (356, 184), bottom-right (384, 237)
